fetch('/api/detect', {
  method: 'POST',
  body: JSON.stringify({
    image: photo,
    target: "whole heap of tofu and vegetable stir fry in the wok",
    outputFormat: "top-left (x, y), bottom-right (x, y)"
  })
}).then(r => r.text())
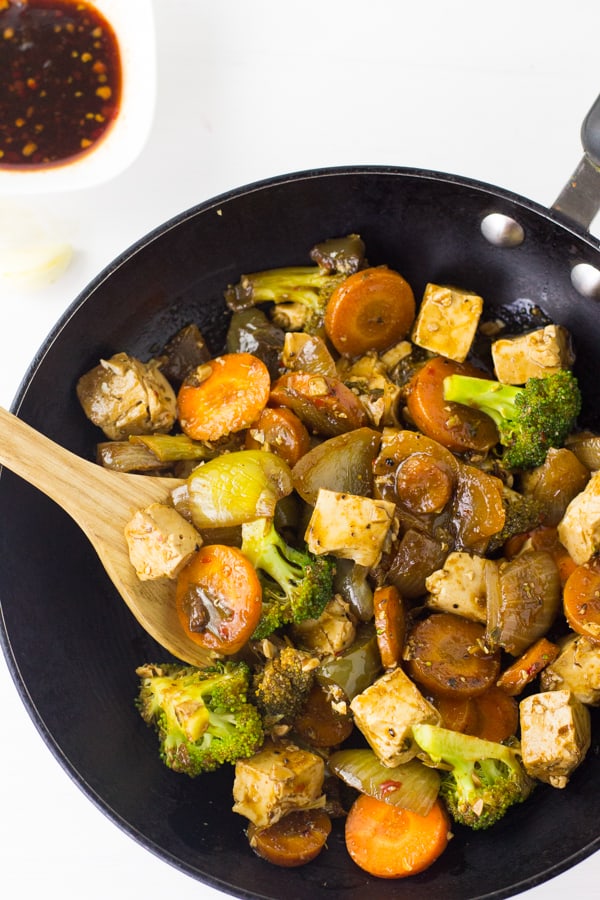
top-left (78, 234), bottom-right (600, 878)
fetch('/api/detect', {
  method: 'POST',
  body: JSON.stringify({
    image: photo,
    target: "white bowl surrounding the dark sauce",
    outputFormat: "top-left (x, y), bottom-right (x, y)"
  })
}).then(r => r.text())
top-left (0, 0), bottom-right (156, 196)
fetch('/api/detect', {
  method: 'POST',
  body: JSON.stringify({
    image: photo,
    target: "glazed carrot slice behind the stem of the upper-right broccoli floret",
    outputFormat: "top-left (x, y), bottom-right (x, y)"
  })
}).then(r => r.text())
top-left (406, 356), bottom-right (498, 453)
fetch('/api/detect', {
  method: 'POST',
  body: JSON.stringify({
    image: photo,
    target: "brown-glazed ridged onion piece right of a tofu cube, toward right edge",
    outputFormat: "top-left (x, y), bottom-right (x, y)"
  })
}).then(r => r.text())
top-left (485, 550), bottom-right (561, 656)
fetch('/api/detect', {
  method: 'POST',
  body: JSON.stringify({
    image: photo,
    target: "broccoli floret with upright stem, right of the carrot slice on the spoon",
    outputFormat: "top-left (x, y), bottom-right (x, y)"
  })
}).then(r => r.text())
top-left (241, 518), bottom-right (335, 640)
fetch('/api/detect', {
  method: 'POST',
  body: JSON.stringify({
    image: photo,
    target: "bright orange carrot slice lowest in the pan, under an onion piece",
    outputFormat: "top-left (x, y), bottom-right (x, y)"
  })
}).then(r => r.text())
top-left (346, 794), bottom-right (450, 878)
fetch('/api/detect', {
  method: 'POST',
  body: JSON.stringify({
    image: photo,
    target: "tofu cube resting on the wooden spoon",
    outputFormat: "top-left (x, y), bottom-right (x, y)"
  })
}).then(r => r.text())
top-left (125, 503), bottom-right (202, 581)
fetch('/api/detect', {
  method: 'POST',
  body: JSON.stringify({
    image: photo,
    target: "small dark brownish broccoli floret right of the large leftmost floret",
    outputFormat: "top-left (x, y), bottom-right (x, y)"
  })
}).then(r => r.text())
top-left (253, 647), bottom-right (318, 729)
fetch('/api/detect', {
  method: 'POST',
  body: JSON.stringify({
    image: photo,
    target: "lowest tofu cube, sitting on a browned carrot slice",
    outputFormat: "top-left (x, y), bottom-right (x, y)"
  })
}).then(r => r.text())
top-left (233, 741), bottom-right (325, 828)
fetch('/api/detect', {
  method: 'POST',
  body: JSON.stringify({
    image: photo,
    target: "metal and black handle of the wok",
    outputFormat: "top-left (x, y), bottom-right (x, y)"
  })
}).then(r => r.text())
top-left (552, 96), bottom-right (600, 229)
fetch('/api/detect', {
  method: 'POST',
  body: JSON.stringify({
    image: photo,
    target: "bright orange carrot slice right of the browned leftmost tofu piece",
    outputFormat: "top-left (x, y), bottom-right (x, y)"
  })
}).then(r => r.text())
top-left (177, 353), bottom-right (271, 441)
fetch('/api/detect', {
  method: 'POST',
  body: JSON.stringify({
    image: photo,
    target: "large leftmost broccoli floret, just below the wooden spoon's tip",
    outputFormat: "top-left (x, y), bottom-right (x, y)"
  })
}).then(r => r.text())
top-left (136, 660), bottom-right (264, 777)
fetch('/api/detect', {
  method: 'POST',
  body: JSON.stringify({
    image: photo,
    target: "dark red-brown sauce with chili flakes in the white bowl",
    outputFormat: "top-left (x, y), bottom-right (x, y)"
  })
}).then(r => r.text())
top-left (0, 0), bottom-right (122, 168)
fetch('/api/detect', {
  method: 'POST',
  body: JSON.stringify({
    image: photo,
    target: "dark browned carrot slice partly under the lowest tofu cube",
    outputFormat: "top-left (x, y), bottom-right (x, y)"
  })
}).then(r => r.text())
top-left (248, 809), bottom-right (331, 869)
